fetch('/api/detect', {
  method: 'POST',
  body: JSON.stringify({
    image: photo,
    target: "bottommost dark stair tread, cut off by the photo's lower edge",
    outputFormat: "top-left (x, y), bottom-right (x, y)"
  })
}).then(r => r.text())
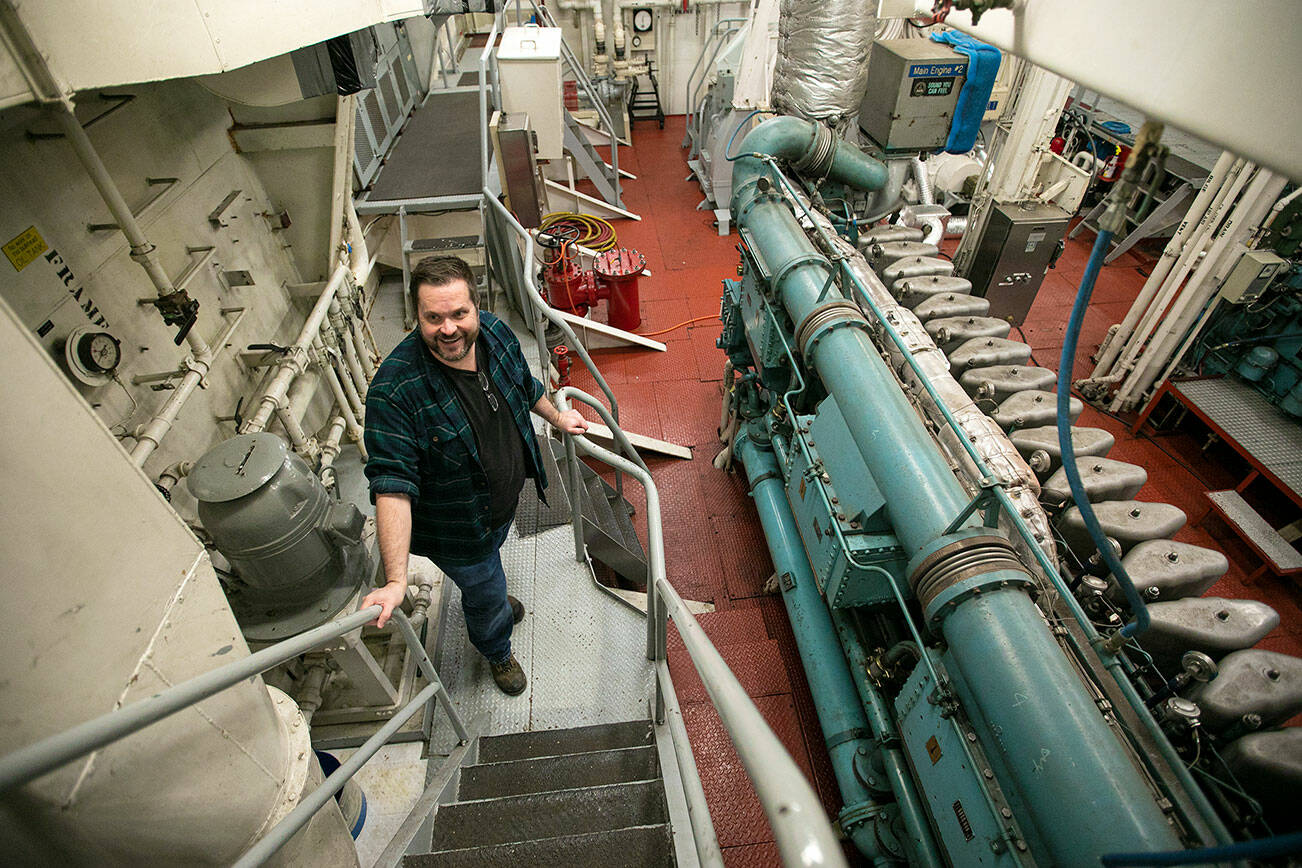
top-left (402, 824), bottom-right (674, 868)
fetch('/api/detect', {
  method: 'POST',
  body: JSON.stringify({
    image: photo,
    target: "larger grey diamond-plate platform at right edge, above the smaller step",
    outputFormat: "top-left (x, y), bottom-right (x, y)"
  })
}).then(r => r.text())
top-left (1170, 379), bottom-right (1302, 497)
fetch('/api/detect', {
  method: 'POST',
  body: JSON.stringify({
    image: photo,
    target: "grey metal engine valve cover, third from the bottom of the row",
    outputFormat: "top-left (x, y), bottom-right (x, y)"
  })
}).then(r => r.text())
top-left (1139, 598), bottom-right (1280, 664)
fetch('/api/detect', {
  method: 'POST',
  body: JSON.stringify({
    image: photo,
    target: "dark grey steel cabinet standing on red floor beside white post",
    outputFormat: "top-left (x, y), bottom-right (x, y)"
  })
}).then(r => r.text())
top-left (967, 203), bottom-right (1072, 325)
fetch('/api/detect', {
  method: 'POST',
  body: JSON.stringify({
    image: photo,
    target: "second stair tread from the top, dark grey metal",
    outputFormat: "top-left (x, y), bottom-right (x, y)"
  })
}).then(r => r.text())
top-left (460, 744), bottom-right (660, 802)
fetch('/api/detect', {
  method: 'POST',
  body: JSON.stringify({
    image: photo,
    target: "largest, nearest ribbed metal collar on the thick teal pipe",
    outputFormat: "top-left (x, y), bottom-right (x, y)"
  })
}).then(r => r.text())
top-left (909, 528), bottom-right (1031, 619)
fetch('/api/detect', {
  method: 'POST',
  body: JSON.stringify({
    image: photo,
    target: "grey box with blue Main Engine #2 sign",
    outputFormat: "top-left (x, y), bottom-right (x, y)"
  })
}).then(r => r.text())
top-left (859, 39), bottom-right (967, 151)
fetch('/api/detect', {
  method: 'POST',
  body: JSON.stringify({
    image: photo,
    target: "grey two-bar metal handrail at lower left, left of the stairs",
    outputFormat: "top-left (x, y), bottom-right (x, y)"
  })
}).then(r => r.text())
top-left (0, 605), bottom-right (470, 868)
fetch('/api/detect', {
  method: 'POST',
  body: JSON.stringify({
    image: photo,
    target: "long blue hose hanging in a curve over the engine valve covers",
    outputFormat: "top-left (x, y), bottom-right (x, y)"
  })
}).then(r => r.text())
top-left (1057, 230), bottom-right (1148, 636)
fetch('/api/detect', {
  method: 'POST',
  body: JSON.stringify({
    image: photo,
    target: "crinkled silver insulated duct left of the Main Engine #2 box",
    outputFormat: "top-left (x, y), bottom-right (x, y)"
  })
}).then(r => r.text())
top-left (772, 0), bottom-right (876, 133)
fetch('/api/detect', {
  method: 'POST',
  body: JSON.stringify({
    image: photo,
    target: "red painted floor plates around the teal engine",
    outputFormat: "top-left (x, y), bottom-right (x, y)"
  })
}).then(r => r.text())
top-left (562, 116), bottom-right (1302, 867)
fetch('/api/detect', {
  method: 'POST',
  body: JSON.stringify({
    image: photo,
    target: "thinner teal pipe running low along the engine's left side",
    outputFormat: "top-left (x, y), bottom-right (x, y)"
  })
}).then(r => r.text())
top-left (736, 433), bottom-right (944, 868)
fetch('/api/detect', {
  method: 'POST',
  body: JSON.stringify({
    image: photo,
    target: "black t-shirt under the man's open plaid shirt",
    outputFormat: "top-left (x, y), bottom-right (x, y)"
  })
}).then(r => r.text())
top-left (444, 337), bottom-right (525, 528)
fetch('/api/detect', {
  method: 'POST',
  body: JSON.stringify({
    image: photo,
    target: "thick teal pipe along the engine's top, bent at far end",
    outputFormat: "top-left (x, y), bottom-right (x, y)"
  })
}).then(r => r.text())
top-left (732, 117), bottom-right (1180, 864)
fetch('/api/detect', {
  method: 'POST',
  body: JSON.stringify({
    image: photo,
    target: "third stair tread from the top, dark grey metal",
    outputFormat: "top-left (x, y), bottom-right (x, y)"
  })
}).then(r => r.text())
top-left (431, 781), bottom-right (668, 852)
